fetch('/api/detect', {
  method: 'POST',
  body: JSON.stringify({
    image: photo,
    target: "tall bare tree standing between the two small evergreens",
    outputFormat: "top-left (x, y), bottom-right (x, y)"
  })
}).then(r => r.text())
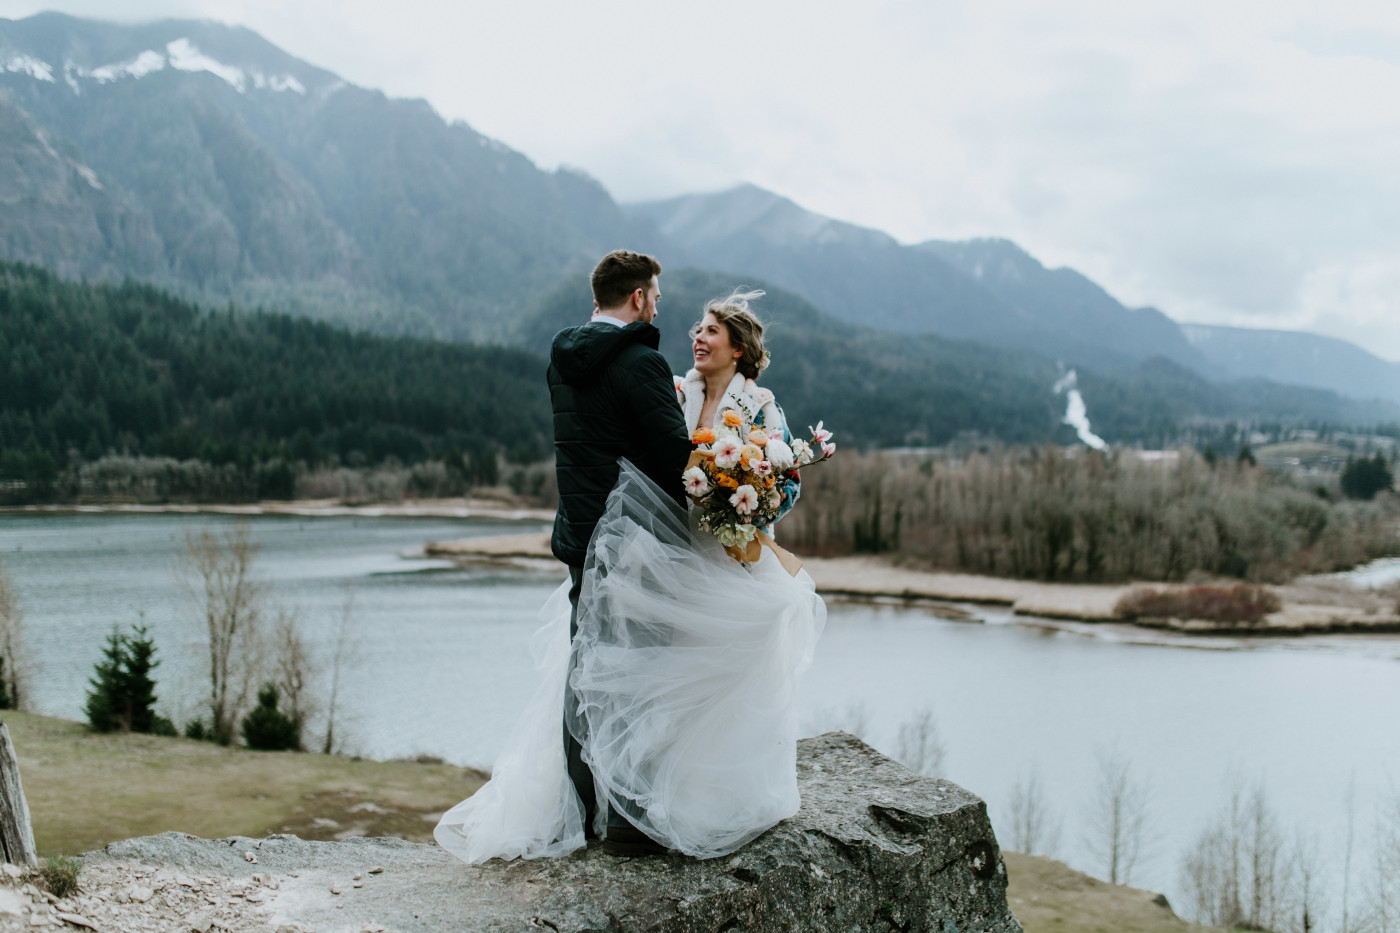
top-left (179, 521), bottom-right (267, 744)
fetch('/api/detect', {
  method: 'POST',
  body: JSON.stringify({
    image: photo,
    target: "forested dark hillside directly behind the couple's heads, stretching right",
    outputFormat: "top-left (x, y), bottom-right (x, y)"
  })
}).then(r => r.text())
top-left (515, 269), bottom-right (1397, 448)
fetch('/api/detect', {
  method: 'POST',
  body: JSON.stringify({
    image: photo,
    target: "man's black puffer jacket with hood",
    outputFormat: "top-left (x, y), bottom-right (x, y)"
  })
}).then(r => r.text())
top-left (549, 321), bottom-right (690, 567)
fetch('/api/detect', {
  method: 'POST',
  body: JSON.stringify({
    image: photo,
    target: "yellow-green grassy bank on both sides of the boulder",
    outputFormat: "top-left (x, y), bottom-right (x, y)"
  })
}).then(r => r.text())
top-left (16, 712), bottom-right (1232, 933)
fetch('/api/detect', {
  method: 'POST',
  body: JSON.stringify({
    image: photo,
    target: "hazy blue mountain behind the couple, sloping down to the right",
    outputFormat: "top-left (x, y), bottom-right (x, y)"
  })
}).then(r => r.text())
top-left (626, 185), bottom-right (1205, 370)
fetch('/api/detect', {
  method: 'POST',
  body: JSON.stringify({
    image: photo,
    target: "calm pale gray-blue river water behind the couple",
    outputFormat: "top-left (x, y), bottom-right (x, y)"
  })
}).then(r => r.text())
top-left (0, 513), bottom-right (1400, 894)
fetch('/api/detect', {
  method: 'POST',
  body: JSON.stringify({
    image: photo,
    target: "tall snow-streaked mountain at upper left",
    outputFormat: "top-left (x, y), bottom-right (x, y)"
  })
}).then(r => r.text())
top-left (0, 14), bottom-right (644, 338)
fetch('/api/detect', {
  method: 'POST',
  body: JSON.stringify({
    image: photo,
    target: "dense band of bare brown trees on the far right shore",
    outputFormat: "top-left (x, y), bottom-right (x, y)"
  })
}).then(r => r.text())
top-left (780, 445), bottom-right (1400, 583)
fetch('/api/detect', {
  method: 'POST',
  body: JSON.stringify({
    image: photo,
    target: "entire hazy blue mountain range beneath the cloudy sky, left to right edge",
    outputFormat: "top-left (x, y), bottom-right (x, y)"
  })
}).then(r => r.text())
top-left (0, 14), bottom-right (1400, 411)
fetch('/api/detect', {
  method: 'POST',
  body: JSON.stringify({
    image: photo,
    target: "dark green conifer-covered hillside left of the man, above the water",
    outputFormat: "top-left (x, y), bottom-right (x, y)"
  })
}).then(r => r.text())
top-left (0, 262), bottom-right (550, 499)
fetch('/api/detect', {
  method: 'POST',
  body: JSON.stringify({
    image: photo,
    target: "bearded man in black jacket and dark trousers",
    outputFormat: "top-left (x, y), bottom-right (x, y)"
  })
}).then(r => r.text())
top-left (547, 249), bottom-right (690, 855)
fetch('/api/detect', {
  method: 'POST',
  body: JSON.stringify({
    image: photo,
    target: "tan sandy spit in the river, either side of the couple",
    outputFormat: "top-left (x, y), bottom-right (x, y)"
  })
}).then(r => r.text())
top-left (423, 532), bottom-right (1400, 639)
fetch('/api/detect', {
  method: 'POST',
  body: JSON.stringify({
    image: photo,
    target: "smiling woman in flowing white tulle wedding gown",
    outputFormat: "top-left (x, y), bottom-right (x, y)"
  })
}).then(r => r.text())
top-left (434, 291), bottom-right (826, 863)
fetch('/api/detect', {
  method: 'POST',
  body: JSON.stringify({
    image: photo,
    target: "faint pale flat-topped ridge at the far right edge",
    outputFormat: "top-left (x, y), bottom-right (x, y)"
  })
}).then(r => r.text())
top-left (1182, 324), bottom-right (1400, 402)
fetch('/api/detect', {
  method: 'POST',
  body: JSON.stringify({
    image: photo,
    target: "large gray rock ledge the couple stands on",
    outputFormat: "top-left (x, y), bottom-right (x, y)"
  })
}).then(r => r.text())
top-left (84, 733), bottom-right (1021, 933)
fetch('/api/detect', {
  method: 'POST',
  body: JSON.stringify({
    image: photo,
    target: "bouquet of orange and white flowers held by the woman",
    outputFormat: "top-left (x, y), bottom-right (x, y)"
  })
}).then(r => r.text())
top-left (680, 408), bottom-right (836, 549)
